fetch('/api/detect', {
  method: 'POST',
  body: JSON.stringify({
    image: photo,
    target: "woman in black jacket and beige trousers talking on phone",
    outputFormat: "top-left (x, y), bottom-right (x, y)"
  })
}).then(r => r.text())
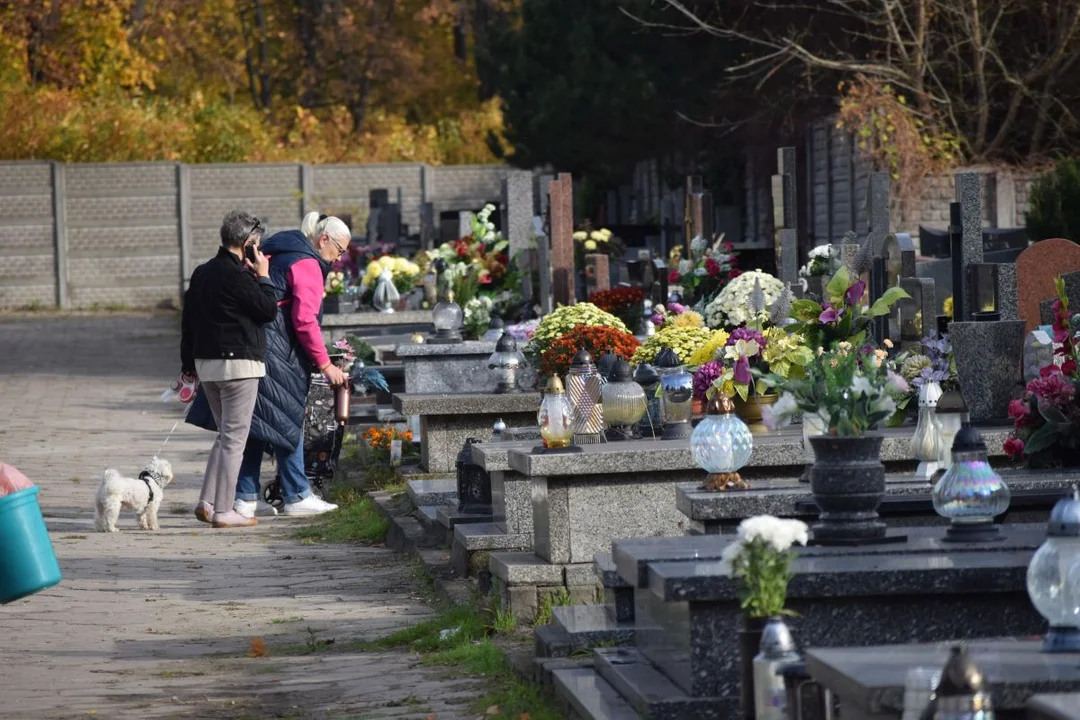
top-left (180, 210), bottom-right (278, 528)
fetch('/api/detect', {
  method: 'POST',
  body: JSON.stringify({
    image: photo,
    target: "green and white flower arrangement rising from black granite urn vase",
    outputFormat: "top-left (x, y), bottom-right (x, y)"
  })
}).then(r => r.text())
top-left (762, 340), bottom-right (908, 437)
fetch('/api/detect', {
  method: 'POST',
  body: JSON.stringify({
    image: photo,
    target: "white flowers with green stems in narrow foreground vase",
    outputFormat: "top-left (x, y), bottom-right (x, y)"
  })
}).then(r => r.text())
top-left (720, 515), bottom-right (809, 617)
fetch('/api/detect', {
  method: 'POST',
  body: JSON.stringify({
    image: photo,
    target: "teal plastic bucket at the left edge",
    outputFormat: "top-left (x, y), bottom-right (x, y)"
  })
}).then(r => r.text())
top-left (0, 488), bottom-right (60, 604)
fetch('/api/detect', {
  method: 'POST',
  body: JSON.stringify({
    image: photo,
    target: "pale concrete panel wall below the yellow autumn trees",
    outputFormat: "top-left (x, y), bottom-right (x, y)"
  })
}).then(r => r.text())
top-left (0, 162), bottom-right (508, 309)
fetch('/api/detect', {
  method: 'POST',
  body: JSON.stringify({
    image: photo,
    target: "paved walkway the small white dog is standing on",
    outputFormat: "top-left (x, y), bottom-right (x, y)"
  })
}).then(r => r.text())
top-left (0, 314), bottom-right (480, 720)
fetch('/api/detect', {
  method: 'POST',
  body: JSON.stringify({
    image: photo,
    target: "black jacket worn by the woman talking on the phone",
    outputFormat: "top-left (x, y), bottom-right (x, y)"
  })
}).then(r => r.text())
top-left (180, 247), bottom-right (278, 372)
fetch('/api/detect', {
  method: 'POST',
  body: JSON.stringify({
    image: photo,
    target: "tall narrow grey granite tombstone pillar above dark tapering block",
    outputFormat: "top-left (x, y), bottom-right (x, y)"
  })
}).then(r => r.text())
top-left (949, 173), bottom-right (983, 322)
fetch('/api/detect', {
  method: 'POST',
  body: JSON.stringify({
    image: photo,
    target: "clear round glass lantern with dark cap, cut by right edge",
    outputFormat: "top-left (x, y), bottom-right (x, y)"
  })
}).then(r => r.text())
top-left (1027, 487), bottom-right (1080, 653)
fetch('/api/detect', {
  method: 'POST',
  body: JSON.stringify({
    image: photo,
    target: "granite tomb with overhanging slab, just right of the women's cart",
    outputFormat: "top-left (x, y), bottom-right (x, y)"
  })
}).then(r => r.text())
top-left (393, 395), bottom-right (540, 473)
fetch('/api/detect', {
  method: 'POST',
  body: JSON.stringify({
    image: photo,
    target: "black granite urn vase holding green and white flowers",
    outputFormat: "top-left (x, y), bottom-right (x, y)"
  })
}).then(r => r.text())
top-left (810, 435), bottom-right (886, 545)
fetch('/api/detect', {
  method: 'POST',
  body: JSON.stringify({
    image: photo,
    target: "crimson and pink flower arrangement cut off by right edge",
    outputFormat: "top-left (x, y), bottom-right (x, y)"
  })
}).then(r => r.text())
top-left (1004, 276), bottom-right (1080, 468)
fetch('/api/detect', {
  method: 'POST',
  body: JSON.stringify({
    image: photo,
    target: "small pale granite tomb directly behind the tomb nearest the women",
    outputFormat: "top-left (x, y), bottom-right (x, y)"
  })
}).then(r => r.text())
top-left (395, 340), bottom-right (498, 395)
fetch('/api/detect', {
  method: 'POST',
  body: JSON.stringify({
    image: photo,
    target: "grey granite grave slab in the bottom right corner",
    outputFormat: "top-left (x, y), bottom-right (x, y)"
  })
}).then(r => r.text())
top-left (806, 628), bottom-right (1080, 720)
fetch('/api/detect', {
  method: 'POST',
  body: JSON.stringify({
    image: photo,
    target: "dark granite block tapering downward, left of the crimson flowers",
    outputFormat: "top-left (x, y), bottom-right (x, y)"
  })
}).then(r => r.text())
top-left (948, 321), bottom-right (1024, 423)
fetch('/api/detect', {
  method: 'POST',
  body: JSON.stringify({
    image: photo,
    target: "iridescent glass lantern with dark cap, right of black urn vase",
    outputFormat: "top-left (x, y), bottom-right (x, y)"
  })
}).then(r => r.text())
top-left (931, 425), bottom-right (1010, 543)
